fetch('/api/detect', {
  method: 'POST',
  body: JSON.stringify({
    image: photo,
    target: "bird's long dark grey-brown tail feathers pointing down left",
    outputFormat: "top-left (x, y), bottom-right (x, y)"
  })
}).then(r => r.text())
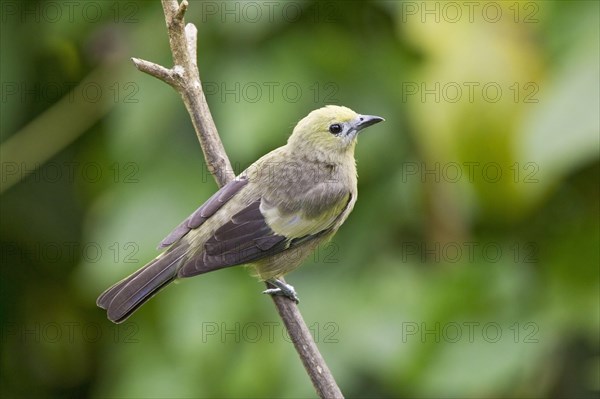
top-left (96, 247), bottom-right (186, 323)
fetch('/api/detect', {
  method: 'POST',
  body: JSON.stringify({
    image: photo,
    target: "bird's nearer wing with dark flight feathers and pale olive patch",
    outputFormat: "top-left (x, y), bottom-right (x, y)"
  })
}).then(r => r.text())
top-left (178, 193), bottom-right (352, 277)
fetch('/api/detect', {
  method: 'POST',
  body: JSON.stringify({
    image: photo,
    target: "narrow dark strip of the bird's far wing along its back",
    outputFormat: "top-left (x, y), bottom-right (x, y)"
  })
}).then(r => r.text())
top-left (158, 177), bottom-right (248, 249)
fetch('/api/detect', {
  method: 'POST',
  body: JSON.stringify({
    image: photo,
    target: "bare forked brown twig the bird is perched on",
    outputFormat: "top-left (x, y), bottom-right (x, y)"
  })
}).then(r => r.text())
top-left (132, 0), bottom-right (343, 398)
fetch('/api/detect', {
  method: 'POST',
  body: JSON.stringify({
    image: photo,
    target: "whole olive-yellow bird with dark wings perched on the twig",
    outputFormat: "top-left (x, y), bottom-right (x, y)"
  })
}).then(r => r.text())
top-left (96, 105), bottom-right (384, 323)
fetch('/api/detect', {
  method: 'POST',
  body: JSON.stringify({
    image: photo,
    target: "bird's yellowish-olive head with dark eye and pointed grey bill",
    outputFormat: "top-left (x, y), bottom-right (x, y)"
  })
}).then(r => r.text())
top-left (288, 105), bottom-right (384, 162)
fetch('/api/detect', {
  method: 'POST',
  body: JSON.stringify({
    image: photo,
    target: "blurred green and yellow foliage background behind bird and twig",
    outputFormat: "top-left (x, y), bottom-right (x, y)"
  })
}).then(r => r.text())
top-left (0, 1), bottom-right (600, 398)
